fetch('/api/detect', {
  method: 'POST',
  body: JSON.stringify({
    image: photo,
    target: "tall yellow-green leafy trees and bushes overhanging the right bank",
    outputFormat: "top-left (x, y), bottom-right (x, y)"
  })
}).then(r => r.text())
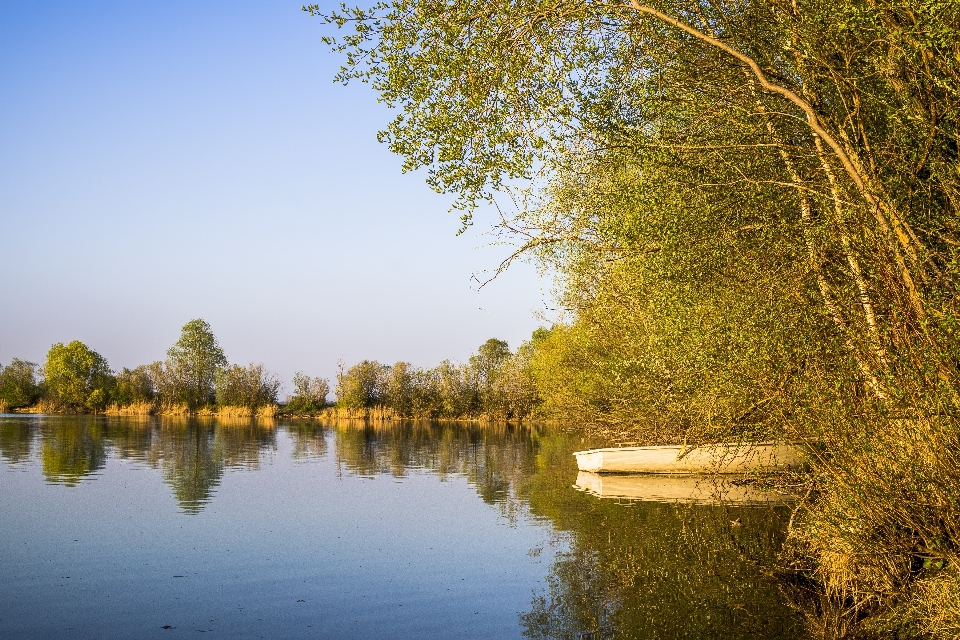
top-left (308, 0), bottom-right (960, 624)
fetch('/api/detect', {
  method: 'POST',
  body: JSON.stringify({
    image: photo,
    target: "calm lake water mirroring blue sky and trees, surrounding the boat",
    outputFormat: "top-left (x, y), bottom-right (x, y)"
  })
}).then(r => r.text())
top-left (0, 416), bottom-right (801, 640)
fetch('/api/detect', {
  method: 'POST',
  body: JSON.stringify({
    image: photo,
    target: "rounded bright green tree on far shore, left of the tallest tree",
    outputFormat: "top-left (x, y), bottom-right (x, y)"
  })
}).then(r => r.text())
top-left (43, 340), bottom-right (114, 410)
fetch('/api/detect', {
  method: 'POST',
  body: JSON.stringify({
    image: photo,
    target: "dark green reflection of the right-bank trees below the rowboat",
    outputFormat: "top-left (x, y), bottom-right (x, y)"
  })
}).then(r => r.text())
top-left (521, 438), bottom-right (803, 639)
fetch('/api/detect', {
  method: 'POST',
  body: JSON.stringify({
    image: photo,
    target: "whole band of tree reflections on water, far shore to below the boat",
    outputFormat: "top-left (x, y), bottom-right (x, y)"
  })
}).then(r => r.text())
top-left (0, 416), bottom-right (802, 640)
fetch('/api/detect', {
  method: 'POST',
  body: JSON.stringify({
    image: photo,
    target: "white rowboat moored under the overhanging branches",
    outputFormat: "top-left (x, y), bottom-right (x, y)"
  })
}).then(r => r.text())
top-left (573, 442), bottom-right (803, 473)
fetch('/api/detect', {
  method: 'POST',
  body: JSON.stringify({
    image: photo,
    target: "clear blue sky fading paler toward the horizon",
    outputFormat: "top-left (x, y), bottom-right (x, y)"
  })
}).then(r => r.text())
top-left (0, 0), bottom-right (546, 390)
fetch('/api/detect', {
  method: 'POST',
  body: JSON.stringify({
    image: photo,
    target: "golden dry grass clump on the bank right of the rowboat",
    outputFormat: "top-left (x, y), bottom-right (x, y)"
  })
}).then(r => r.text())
top-left (788, 416), bottom-right (960, 638)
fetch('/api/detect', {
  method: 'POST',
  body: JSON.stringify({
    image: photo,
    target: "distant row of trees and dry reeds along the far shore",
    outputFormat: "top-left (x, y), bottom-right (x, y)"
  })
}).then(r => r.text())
top-left (0, 319), bottom-right (547, 420)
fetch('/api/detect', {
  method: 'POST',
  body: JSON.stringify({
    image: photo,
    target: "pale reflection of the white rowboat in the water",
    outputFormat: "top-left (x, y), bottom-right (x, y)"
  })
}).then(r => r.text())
top-left (575, 471), bottom-right (785, 506)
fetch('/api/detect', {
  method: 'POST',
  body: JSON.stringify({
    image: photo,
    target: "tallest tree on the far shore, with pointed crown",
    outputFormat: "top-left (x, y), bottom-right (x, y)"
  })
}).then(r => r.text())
top-left (167, 318), bottom-right (227, 407)
